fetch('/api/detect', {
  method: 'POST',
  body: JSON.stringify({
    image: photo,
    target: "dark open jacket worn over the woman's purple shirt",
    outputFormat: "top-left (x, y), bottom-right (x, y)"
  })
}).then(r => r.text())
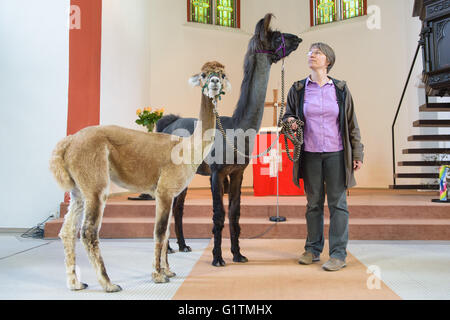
top-left (283, 77), bottom-right (364, 188)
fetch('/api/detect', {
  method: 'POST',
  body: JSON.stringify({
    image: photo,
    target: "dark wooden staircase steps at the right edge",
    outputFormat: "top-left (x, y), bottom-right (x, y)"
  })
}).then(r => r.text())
top-left (389, 103), bottom-right (450, 190)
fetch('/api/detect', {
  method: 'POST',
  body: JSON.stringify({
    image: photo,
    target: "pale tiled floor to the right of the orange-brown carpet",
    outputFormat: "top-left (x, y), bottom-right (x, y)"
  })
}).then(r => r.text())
top-left (348, 240), bottom-right (450, 300)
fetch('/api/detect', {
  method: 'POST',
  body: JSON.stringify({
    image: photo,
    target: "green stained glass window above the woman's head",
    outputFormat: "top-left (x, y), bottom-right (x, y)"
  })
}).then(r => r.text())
top-left (310, 0), bottom-right (367, 26)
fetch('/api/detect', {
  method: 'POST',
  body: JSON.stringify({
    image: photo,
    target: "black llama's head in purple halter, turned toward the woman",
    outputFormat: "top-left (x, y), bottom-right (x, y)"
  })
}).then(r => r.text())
top-left (249, 13), bottom-right (302, 63)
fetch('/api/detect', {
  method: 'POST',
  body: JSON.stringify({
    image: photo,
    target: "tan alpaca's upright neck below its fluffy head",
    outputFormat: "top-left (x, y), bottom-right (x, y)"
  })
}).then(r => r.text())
top-left (190, 94), bottom-right (216, 162)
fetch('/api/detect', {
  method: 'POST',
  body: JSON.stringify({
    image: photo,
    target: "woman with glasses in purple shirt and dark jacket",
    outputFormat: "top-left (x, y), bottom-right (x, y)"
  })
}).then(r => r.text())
top-left (283, 43), bottom-right (364, 271)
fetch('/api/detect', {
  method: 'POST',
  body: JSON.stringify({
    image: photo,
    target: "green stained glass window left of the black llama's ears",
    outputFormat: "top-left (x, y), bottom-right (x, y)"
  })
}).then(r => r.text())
top-left (187, 0), bottom-right (241, 28)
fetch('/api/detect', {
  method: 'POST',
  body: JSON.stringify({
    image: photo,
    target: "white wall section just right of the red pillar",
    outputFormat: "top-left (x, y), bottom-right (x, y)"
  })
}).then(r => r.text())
top-left (100, 0), bottom-right (151, 193)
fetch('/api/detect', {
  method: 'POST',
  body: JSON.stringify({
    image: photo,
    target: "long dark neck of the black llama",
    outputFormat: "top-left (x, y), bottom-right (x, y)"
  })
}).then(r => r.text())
top-left (233, 54), bottom-right (271, 132)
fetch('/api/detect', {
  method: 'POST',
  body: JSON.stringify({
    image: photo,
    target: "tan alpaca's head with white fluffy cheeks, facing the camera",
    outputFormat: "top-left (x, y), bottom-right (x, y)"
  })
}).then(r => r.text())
top-left (189, 61), bottom-right (231, 99)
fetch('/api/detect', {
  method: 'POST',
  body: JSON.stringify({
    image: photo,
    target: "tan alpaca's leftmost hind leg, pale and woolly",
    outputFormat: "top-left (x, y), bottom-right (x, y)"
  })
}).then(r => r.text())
top-left (59, 189), bottom-right (87, 290)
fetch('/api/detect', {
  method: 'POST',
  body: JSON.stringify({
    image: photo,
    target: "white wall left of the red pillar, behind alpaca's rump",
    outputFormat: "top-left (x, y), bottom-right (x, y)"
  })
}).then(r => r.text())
top-left (0, 0), bottom-right (69, 228)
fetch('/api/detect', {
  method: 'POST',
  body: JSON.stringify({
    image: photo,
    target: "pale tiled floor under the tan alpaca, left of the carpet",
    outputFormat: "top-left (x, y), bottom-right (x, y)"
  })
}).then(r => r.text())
top-left (0, 235), bottom-right (209, 300)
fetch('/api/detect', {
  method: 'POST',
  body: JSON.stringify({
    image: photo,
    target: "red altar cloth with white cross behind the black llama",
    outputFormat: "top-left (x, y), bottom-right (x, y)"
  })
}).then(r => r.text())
top-left (252, 128), bottom-right (305, 196)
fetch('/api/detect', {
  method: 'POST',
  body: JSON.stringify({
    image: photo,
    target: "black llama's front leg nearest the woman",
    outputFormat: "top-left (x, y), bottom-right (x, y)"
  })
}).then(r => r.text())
top-left (228, 170), bottom-right (248, 262)
